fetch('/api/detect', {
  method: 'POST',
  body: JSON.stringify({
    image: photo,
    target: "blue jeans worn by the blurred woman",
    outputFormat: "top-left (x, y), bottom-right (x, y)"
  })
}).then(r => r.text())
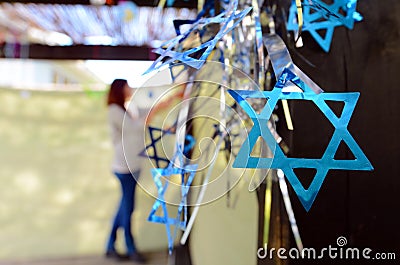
top-left (107, 170), bottom-right (140, 255)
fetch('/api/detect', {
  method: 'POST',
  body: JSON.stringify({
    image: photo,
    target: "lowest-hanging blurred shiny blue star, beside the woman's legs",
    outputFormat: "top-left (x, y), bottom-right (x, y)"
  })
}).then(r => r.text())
top-left (147, 154), bottom-right (197, 254)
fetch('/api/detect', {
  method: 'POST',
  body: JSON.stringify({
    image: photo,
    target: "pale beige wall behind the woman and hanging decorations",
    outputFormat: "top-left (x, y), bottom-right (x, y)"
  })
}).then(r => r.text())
top-left (0, 85), bottom-right (257, 265)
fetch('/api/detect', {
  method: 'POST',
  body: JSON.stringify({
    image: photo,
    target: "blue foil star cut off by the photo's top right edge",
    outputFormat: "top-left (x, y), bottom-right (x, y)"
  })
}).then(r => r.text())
top-left (287, 0), bottom-right (362, 52)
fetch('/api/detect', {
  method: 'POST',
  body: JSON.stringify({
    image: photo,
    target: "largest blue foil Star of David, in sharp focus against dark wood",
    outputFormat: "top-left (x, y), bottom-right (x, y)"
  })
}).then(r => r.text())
top-left (228, 68), bottom-right (373, 211)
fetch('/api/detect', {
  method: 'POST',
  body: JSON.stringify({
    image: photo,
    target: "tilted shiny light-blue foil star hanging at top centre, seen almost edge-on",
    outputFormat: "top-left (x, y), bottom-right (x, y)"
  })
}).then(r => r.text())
top-left (144, 1), bottom-right (251, 74)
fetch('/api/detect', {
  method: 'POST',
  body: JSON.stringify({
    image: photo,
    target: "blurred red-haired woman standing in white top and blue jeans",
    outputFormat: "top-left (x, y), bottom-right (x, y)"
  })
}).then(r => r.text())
top-left (106, 79), bottom-right (145, 262)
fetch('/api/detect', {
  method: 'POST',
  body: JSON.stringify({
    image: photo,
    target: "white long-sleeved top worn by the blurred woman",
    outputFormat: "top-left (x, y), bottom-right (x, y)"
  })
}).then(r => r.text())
top-left (108, 104), bottom-right (145, 173)
